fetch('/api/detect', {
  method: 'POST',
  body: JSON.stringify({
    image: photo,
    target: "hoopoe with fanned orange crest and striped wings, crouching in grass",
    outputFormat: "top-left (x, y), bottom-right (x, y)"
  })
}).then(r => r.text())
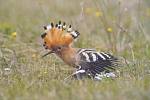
top-left (41, 21), bottom-right (118, 80)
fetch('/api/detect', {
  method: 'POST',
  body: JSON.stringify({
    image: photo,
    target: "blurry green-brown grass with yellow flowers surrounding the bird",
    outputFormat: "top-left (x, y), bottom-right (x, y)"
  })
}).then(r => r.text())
top-left (0, 0), bottom-right (150, 100)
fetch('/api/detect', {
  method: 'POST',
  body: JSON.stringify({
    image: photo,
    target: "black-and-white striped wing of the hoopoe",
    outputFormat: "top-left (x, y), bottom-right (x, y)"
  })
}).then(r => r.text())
top-left (78, 49), bottom-right (118, 76)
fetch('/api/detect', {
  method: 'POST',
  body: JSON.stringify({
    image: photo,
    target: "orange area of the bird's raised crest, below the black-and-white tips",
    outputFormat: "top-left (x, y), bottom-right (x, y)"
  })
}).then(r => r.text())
top-left (43, 21), bottom-right (74, 49)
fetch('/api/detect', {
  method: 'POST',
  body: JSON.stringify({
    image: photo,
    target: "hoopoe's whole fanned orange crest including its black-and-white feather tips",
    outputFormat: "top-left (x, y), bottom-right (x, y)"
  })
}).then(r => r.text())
top-left (41, 21), bottom-right (80, 49)
